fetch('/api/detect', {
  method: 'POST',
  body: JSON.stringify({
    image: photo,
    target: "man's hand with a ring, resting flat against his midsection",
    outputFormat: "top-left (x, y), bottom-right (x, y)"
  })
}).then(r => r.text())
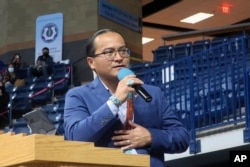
top-left (112, 121), bottom-right (152, 150)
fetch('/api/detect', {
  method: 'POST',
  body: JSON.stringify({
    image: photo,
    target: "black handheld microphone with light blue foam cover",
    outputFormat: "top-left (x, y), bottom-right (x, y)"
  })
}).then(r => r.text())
top-left (117, 68), bottom-right (152, 103)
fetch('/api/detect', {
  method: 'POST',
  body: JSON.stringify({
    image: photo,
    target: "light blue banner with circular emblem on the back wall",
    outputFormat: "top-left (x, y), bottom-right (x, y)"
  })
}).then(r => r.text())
top-left (35, 13), bottom-right (63, 62)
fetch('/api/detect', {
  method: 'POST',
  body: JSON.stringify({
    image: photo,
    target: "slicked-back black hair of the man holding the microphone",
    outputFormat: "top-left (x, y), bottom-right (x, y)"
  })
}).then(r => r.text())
top-left (85, 29), bottom-right (120, 57)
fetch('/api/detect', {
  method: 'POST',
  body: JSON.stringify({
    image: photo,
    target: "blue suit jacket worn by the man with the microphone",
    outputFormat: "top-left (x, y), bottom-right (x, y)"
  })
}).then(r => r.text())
top-left (64, 77), bottom-right (189, 167)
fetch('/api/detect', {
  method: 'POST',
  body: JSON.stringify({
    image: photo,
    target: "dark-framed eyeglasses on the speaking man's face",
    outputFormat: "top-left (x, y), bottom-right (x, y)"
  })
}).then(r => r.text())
top-left (93, 47), bottom-right (130, 61)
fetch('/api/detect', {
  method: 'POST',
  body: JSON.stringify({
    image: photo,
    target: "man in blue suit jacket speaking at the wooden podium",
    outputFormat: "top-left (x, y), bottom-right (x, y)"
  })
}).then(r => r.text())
top-left (64, 29), bottom-right (190, 167)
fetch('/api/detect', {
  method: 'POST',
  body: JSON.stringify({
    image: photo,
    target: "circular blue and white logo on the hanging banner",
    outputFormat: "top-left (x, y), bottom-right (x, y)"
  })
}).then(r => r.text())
top-left (41, 23), bottom-right (58, 43)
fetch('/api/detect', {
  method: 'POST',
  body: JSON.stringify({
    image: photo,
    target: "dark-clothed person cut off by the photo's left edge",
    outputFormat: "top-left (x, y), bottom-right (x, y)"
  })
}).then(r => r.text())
top-left (0, 81), bottom-right (10, 126)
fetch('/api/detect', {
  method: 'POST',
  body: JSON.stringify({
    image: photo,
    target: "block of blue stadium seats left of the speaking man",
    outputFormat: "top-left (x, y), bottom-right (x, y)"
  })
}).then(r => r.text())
top-left (1, 63), bottom-right (71, 134)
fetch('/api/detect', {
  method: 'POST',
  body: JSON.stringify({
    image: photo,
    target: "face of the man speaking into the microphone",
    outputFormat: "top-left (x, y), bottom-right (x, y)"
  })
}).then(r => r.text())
top-left (88, 32), bottom-right (129, 78)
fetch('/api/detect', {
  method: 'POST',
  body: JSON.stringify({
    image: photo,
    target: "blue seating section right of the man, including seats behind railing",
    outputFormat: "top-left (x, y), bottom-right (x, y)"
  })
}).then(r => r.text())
top-left (131, 36), bottom-right (250, 137)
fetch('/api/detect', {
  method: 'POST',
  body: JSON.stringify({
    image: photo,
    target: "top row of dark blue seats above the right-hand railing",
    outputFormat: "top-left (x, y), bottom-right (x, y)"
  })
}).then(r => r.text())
top-left (131, 35), bottom-right (250, 75)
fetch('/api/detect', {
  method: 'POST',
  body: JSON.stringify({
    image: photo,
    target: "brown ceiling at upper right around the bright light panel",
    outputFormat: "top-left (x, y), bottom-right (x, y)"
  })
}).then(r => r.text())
top-left (142, 0), bottom-right (250, 61)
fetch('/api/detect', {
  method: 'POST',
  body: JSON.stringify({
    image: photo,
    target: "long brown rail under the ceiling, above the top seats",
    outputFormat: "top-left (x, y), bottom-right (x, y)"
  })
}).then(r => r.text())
top-left (161, 23), bottom-right (250, 41)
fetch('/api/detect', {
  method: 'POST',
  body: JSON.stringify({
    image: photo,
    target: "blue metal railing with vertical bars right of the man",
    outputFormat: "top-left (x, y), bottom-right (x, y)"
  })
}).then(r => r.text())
top-left (138, 37), bottom-right (250, 153)
